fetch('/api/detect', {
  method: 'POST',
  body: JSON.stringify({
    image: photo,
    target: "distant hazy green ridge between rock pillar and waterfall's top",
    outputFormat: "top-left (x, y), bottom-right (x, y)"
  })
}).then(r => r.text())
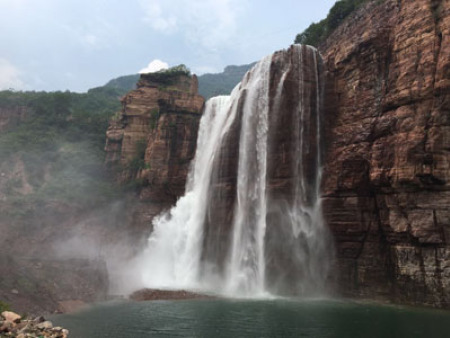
top-left (198, 63), bottom-right (254, 99)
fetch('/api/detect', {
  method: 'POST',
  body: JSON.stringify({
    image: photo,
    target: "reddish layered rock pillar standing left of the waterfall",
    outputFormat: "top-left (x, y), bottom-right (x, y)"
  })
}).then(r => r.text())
top-left (106, 73), bottom-right (204, 236)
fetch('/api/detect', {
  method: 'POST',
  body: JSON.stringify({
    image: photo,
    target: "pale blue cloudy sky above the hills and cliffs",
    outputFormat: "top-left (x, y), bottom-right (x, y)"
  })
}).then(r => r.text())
top-left (0, 0), bottom-right (335, 91)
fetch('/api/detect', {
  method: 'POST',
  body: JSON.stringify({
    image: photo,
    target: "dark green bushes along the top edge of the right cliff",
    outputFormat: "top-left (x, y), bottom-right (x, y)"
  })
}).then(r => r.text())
top-left (295, 0), bottom-right (379, 47)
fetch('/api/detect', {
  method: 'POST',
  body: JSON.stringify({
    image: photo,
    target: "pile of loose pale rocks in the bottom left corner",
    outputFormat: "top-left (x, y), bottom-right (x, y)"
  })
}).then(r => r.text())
top-left (0, 311), bottom-right (69, 338)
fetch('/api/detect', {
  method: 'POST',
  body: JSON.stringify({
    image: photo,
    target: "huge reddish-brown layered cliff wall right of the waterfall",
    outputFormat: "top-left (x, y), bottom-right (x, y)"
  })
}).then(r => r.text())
top-left (321, 0), bottom-right (450, 307)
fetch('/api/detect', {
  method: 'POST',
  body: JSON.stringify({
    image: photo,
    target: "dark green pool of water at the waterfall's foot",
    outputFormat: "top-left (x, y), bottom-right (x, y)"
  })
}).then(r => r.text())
top-left (51, 300), bottom-right (450, 338)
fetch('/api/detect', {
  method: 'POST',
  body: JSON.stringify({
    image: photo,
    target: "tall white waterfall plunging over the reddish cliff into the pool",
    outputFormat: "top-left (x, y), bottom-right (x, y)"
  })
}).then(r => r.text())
top-left (141, 45), bottom-right (331, 296)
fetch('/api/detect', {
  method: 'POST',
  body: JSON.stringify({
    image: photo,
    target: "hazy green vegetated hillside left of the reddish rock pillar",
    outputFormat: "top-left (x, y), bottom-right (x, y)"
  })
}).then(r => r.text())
top-left (0, 87), bottom-right (124, 217)
